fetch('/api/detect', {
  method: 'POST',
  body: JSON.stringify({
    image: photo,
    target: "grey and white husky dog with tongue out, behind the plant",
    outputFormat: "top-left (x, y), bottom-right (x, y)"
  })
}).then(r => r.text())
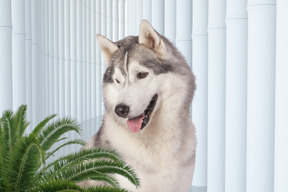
top-left (82, 20), bottom-right (196, 192)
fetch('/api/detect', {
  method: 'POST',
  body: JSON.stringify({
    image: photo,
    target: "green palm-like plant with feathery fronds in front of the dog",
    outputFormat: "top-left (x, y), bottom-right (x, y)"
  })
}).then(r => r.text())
top-left (0, 105), bottom-right (139, 192)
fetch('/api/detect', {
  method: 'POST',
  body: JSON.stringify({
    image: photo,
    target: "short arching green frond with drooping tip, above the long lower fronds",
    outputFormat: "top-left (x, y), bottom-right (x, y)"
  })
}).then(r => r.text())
top-left (38, 118), bottom-right (81, 151)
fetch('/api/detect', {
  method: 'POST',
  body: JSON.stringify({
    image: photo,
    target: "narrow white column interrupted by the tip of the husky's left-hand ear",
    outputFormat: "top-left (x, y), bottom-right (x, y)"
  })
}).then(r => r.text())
top-left (96, 0), bottom-right (102, 117)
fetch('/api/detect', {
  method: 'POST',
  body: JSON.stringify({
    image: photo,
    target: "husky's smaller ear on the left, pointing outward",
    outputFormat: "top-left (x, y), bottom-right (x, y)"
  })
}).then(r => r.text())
top-left (96, 34), bottom-right (118, 66)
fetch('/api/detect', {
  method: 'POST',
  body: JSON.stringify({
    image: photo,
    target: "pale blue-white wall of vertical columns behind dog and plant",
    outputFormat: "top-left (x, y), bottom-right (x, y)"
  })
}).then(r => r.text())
top-left (0, 0), bottom-right (288, 192)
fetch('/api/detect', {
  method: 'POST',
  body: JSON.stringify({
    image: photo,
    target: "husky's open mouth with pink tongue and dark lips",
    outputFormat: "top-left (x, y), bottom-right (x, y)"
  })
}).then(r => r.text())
top-left (127, 94), bottom-right (158, 133)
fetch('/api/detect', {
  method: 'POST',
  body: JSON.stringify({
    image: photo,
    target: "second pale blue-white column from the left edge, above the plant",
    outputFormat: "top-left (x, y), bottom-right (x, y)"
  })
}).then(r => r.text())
top-left (12, 0), bottom-right (26, 110)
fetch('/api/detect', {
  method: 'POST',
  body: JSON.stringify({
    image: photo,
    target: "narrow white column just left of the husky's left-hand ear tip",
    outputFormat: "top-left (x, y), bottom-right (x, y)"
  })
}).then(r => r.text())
top-left (89, 0), bottom-right (97, 118)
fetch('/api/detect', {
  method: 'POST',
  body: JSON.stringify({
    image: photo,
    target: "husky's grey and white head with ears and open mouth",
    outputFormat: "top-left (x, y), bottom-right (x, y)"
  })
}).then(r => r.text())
top-left (97, 20), bottom-right (195, 132)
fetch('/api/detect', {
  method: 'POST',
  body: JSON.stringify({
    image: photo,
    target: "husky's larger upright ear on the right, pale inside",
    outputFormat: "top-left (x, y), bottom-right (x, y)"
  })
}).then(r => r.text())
top-left (138, 19), bottom-right (166, 56)
